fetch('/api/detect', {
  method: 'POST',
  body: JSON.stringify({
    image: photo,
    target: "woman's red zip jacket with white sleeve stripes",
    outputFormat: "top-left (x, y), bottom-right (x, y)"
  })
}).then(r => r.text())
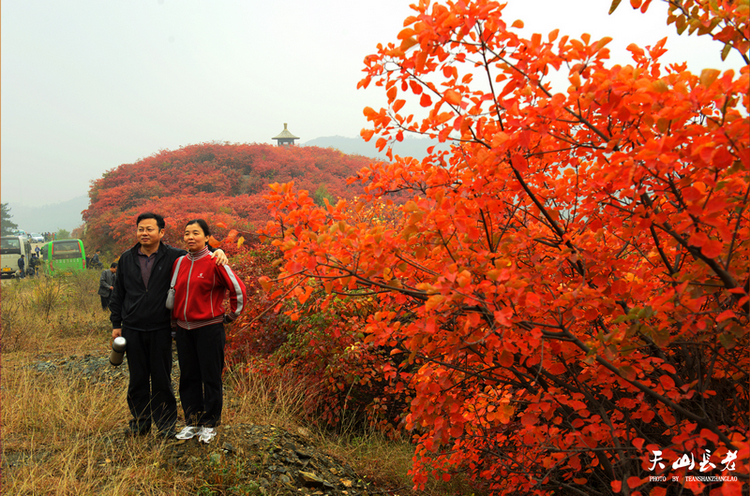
top-left (172, 248), bottom-right (247, 329)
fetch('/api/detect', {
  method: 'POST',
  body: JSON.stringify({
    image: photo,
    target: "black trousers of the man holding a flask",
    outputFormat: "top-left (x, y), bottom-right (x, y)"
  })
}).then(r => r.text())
top-left (122, 328), bottom-right (177, 432)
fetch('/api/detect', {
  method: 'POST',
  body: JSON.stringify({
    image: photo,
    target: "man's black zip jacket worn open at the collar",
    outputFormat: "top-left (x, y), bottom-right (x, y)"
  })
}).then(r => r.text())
top-left (109, 243), bottom-right (187, 331)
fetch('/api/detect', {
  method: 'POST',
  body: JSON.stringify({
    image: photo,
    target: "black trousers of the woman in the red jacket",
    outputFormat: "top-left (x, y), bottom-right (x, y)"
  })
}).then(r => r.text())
top-left (177, 324), bottom-right (226, 427)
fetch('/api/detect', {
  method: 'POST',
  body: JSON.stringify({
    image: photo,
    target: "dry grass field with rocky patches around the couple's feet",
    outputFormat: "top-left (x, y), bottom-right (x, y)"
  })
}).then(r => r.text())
top-left (0, 271), bottom-right (482, 496)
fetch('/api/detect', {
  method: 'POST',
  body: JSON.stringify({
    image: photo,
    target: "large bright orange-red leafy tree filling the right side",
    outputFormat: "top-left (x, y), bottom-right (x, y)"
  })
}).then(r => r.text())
top-left (261, 0), bottom-right (750, 494)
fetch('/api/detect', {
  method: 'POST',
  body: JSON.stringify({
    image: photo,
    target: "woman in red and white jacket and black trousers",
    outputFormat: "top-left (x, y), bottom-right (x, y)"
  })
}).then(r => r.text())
top-left (172, 219), bottom-right (246, 443)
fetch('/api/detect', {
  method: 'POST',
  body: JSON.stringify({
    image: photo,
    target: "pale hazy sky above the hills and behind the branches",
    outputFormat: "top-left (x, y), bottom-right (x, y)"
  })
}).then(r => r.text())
top-left (0, 0), bottom-right (741, 205)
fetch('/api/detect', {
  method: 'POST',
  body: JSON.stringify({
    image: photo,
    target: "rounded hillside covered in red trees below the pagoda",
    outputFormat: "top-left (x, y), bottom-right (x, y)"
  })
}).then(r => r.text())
top-left (83, 143), bottom-right (372, 255)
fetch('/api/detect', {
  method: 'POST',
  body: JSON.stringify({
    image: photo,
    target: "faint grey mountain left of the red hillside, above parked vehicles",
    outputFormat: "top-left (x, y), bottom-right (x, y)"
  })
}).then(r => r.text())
top-left (8, 195), bottom-right (89, 233)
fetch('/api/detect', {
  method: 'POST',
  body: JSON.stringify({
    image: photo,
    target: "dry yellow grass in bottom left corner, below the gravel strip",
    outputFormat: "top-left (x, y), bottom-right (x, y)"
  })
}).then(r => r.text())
top-left (2, 364), bottom-right (181, 494)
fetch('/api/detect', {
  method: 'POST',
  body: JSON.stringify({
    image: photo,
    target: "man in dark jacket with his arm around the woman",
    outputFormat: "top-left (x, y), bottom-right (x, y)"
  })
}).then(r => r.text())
top-left (109, 212), bottom-right (227, 438)
